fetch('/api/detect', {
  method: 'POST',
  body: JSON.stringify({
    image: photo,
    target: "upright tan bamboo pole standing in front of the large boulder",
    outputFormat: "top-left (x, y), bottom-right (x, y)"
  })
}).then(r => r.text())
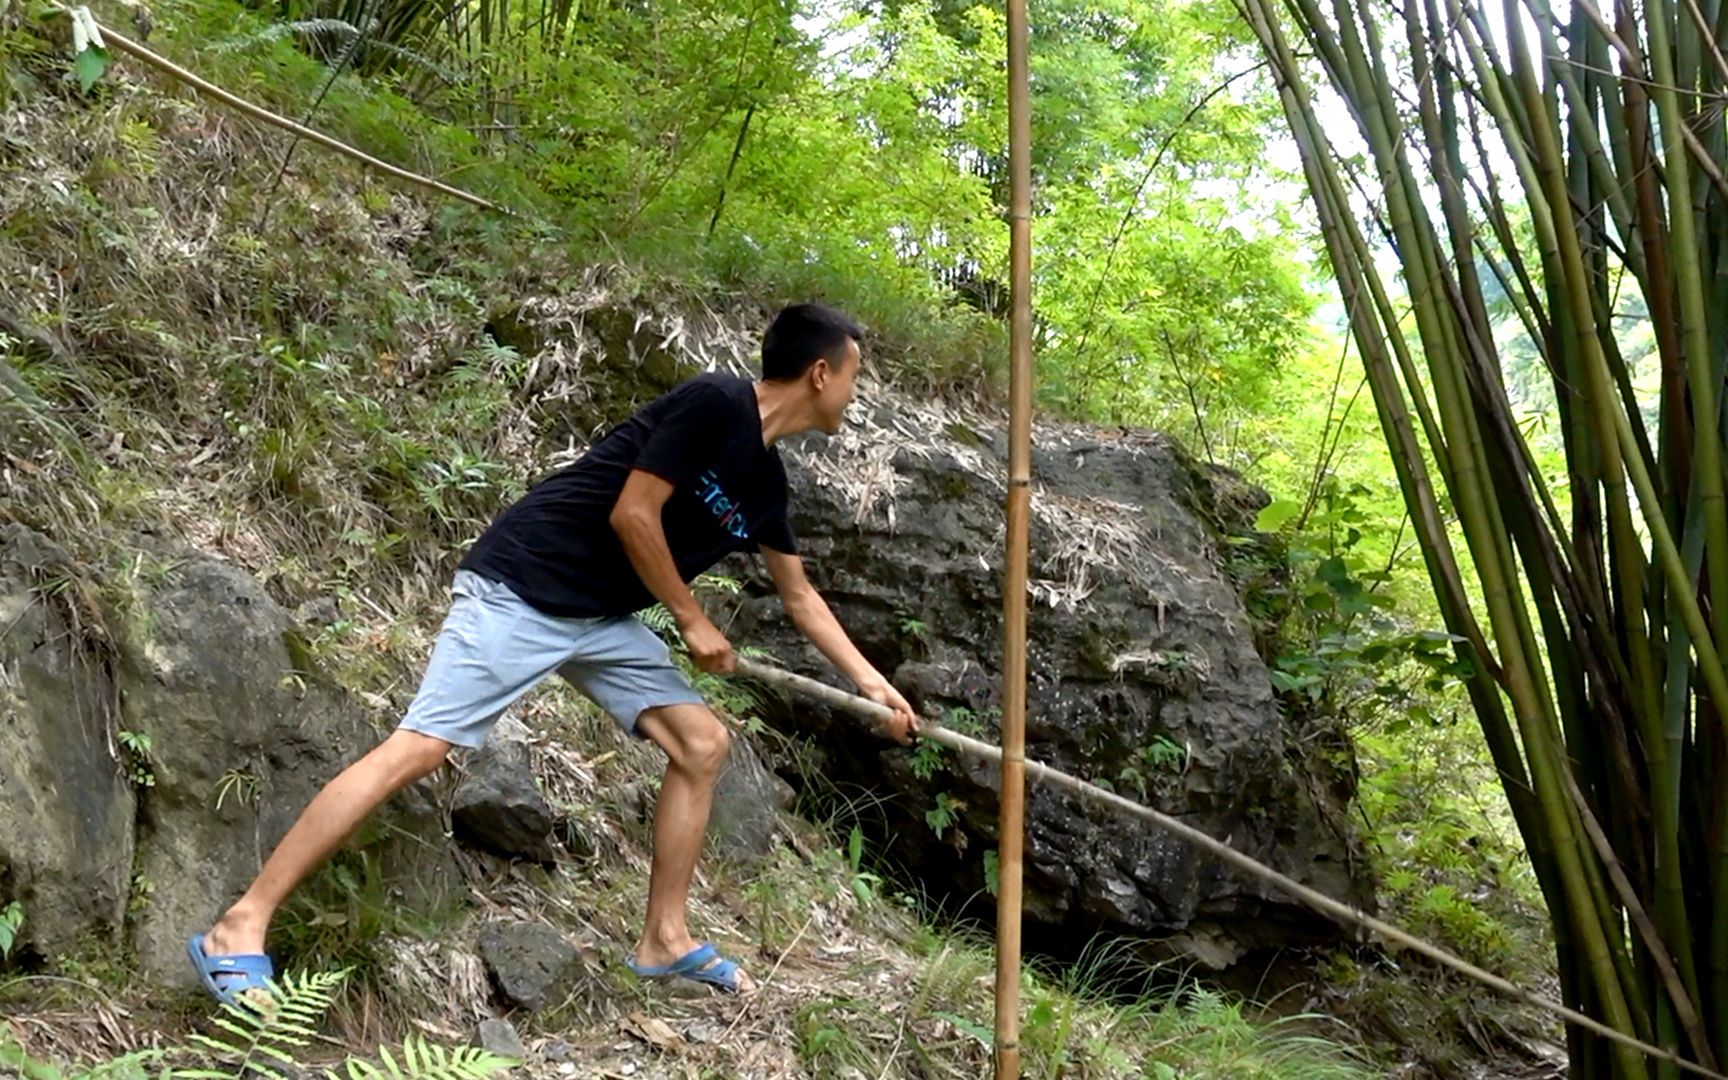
top-left (995, 0), bottom-right (1032, 1080)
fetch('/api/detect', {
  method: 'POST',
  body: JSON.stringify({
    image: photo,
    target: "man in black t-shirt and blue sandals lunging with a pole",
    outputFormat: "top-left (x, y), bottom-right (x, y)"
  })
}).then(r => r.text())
top-left (187, 304), bottom-right (916, 1001)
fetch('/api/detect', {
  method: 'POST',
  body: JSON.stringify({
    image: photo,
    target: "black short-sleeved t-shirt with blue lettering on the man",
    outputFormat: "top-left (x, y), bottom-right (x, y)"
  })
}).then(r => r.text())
top-left (461, 373), bottom-right (797, 617)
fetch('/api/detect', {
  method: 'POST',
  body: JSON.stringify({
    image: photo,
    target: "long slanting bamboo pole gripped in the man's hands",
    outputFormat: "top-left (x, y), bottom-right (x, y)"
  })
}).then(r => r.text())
top-left (738, 657), bottom-right (1728, 1080)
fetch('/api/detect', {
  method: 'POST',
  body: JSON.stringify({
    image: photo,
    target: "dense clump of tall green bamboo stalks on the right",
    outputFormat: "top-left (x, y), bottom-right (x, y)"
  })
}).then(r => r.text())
top-left (1239, 0), bottom-right (1728, 1077)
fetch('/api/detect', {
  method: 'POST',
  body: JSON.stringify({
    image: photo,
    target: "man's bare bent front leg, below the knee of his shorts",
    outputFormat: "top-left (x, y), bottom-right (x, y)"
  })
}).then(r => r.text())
top-left (636, 705), bottom-right (755, 992)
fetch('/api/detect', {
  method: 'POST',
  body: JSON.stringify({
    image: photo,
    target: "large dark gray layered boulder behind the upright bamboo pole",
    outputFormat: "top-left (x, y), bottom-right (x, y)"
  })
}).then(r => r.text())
top-left (733, 399), bottom-right (1372, 966)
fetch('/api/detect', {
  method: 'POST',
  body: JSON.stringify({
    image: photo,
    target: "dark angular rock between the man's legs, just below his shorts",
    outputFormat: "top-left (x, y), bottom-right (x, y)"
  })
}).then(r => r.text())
top-left (451, 726), bottom-right (556, 862)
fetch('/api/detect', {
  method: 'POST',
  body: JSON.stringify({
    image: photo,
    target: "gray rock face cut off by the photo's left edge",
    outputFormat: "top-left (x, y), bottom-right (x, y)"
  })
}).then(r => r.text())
top-left (0, 524), bottom-right (137, 956)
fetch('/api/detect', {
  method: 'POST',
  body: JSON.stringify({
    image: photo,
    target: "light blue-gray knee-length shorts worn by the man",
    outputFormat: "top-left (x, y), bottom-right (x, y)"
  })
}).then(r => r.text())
top-left (401, 570), bottom-right (702, 746)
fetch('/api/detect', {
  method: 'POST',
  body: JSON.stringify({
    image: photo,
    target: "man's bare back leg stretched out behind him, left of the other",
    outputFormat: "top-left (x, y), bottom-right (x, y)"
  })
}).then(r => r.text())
top-left (204, 729), bottom-right (451, 956)
